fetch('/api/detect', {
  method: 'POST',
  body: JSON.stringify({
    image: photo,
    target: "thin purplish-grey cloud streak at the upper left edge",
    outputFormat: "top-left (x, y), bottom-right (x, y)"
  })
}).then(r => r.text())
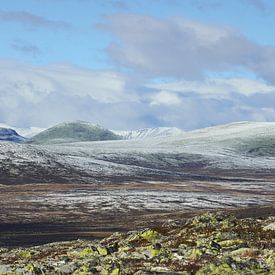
top-left (0, 11), bottom-right (72, 29)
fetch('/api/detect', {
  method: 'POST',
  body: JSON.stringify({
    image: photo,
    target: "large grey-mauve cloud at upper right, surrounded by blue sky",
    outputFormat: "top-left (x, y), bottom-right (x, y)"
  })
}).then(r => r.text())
top-left (100, 14), bottom-right (275, 82)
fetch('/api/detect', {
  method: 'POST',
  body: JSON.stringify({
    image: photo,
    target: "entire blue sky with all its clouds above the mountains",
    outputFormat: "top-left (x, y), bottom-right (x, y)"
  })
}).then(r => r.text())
top-left (0, 0), bottom-right (275, 130)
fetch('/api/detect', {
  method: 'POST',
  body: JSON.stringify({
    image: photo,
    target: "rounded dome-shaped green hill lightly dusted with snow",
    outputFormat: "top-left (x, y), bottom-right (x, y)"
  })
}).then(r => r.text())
top-left (30, 121), bottom-right (121, 144)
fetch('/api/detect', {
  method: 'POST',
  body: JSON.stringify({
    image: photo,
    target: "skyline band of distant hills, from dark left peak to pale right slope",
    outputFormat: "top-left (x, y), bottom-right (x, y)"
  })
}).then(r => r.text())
top-left (0, 121), bottom-right (275, 156)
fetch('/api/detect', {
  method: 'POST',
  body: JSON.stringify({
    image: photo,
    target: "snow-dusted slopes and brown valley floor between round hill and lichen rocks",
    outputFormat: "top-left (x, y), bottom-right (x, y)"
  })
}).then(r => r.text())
top-left (0, 122), bottom-right (275, 247)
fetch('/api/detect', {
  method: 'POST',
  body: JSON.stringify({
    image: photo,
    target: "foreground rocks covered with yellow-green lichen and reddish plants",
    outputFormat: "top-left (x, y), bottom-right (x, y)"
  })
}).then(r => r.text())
top-left (0, 212), bottom-right (275, 275)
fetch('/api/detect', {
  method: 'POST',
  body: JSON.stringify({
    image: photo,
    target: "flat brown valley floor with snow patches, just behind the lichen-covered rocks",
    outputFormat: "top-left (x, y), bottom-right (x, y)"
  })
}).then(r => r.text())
top-left (0, 180), bottom-right (275, 247)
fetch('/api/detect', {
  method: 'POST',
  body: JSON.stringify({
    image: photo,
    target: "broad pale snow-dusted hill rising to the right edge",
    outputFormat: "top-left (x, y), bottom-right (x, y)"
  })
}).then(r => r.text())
top-left (165, 121), bottom-right (275, 156)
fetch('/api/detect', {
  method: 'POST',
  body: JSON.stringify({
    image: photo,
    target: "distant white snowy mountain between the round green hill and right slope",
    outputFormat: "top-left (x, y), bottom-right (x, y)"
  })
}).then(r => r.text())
top-left (112, 127), bottom-right (184, 139)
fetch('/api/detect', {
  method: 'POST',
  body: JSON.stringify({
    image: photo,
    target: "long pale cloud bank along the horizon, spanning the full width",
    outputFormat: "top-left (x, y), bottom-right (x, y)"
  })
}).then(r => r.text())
top-left (0, 60), bottom-right (275, 130)
